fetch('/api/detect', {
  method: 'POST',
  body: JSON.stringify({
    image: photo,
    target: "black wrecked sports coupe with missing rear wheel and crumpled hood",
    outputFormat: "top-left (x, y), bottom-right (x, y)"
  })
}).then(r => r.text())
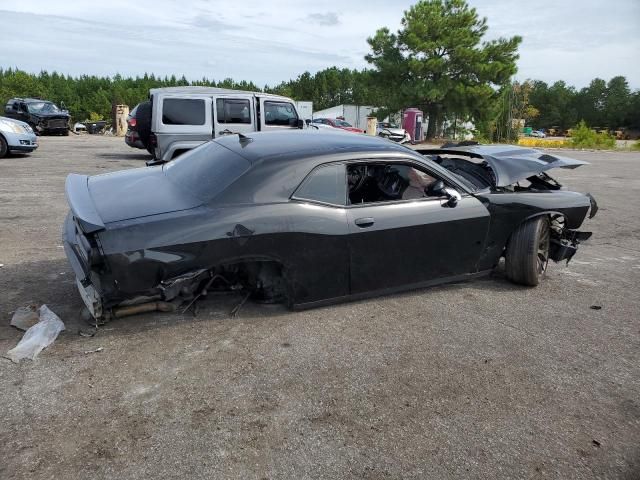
top-left (63, 131), bottom-right (597, 319)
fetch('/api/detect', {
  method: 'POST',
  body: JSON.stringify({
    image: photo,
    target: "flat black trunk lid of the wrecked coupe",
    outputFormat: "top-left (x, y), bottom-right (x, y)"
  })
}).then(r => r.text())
top-left (87, 167), bottom-right (202, 223)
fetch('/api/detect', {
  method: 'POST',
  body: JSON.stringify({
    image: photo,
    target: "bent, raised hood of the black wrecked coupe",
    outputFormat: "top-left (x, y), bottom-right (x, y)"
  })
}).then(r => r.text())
top-left (418, 145), bottom-right (589, 187)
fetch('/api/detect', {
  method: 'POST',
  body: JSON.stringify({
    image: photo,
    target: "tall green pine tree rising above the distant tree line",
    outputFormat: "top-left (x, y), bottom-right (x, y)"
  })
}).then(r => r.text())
top-left (365, 0), bottom-right (522, 138)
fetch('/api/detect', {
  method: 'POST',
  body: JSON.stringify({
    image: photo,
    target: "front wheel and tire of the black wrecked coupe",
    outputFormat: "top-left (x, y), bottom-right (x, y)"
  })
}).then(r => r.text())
top-left (505, 217), bottom-right (551, 286)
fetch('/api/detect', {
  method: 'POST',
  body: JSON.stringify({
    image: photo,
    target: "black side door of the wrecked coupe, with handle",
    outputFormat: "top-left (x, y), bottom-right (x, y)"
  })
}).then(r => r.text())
top-left (347, 161), bottom-right (489, 294)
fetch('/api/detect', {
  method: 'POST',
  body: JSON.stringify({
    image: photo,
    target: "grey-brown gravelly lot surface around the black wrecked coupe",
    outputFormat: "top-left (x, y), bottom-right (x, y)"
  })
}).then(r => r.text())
top-left (0, 136), bottom-right (640, 480)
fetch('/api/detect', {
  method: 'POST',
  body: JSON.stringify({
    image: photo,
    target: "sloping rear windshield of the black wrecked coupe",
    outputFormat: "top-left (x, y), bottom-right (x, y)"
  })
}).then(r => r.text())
top-left (163, 140), bottom-right (251, 202)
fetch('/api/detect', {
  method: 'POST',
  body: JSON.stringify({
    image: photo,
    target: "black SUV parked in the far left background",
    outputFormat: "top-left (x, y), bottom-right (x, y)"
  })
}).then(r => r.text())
top-left (4, 98), bottom-right (70, 135)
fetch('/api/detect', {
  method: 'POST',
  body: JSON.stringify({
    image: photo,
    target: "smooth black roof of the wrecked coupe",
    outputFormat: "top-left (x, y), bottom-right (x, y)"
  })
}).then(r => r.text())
top-left (215, 129), bottom-right (417, 164)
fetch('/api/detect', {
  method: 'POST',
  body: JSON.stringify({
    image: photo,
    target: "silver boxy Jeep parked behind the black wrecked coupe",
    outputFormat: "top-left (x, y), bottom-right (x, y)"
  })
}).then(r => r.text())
top-left (148, 87), bottom-right (304, 163)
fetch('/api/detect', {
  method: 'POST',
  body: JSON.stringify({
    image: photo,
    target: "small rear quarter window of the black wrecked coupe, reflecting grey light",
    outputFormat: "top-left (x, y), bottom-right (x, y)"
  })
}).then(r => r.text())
top-left (293, 164), bottom-right (347, 206)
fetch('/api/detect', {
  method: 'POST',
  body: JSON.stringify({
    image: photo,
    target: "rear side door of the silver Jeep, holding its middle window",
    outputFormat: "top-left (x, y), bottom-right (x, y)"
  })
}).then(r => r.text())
top-left (213, 95), bottom-right (257, 137)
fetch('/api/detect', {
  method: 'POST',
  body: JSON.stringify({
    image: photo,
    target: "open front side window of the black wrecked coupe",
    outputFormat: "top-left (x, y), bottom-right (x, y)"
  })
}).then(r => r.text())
top-left (347, 163), bottom-right (441, 205)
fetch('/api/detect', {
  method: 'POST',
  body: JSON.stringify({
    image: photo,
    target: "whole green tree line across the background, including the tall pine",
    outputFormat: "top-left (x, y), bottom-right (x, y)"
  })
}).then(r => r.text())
top-left (0, 0), bottom-right (640, 140)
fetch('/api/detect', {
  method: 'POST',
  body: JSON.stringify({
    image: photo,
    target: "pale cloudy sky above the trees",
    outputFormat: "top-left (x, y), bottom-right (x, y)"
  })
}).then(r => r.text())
top-left (0, 0), bottom-right (640, 89)
